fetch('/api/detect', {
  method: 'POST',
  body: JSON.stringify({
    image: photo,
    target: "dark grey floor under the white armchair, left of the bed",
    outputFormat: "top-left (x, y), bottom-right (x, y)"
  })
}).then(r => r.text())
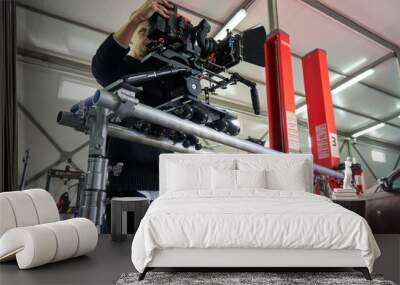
top-left (0, 235), bottom-right (135, 285)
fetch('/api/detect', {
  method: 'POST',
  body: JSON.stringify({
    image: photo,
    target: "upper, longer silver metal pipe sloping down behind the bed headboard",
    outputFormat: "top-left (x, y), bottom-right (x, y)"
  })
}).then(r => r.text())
top-left (93, 92), bottom-right (343, 178)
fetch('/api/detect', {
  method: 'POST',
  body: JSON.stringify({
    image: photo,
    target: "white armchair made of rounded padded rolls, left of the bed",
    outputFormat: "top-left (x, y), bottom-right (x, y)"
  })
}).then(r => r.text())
top-left (0, 189), bottom-right (98, 269)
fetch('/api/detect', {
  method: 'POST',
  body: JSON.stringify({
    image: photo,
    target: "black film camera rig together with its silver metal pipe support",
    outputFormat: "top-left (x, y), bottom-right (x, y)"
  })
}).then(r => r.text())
top-left (57, 7), bottom-right (344, 227)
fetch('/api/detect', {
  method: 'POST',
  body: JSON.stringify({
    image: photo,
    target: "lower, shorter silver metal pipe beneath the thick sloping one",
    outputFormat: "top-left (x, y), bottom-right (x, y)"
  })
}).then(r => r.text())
top-left (107, 124), bottom-right (206, 153)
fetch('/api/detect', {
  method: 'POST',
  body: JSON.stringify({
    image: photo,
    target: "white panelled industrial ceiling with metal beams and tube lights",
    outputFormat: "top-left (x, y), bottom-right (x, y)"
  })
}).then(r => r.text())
top-left (17, 0), bottom-right (400, 146)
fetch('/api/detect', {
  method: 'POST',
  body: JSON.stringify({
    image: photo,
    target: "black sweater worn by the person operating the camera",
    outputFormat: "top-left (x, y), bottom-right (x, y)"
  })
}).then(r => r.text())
top-left (92, 35), bottom-right (177, 193)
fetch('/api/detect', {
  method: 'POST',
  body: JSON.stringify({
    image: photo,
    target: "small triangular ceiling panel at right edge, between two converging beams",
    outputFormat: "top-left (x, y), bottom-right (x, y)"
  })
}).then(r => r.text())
top-left (363, 58), bottom-right (400, 97)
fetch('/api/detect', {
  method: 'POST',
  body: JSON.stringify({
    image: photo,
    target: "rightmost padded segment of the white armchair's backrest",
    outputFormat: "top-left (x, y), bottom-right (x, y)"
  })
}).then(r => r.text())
top-left (22, 189), bottom-right (60, 224)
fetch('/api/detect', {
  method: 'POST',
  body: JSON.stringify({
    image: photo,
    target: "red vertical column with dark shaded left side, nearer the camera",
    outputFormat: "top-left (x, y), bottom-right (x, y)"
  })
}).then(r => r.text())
top-left (264, 30), bottom-right (300, 153)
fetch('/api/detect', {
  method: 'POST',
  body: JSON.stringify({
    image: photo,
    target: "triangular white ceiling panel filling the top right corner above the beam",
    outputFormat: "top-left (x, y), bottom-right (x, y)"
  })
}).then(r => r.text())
top-left (320, 0), bottom-right (400, 46)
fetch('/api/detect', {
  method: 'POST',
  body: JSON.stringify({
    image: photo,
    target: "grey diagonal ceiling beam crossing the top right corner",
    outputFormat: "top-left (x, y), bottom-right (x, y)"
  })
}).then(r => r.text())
top-left (302, 0), bottom-right (400, 52)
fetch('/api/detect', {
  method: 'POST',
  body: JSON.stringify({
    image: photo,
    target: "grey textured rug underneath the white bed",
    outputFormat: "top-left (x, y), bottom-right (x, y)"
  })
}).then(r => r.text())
top-left (117, 272), bottom-right (395, 285)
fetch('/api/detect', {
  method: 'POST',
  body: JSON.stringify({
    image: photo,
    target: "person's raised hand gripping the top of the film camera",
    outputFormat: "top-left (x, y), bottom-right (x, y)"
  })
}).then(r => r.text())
top-left (132, 0), bottom-right (173, 22)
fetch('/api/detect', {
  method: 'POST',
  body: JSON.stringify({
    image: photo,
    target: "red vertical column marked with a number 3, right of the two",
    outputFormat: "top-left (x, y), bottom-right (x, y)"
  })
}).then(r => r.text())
top-left (302, 49), bottom-right (340, 168)
